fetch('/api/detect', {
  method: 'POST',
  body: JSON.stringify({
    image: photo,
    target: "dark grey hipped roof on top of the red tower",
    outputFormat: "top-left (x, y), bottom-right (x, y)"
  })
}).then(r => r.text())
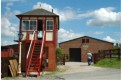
top-left (16, 8), bottom-right (58, 17)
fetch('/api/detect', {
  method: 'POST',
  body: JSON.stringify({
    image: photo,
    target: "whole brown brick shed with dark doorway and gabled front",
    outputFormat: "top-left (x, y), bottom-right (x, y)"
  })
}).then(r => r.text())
top-left (59, 36), bottom-right (113, 62)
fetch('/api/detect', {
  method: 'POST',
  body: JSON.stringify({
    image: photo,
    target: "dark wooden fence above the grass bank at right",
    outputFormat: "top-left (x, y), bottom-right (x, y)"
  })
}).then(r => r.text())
top-left (93, 49), bottom-right (121, 64)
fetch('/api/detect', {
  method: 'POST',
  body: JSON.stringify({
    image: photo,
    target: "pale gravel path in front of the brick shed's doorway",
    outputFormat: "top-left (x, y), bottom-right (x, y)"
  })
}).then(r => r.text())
top-left (58, 62), bottom-right (102, 74)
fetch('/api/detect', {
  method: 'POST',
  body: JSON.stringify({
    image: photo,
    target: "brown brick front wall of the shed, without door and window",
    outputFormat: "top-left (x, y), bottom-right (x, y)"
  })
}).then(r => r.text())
top-left (59, 37), bottom-right (113, 62)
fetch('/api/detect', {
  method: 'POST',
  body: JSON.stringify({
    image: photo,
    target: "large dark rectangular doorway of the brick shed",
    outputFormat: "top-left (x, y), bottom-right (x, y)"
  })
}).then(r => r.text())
top-left (69, 48), bottom-right (81, 62)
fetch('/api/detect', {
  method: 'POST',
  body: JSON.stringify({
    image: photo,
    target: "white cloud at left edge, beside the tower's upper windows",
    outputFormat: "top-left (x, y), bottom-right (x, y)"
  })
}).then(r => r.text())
top-left (1, 17), bottom-right (16, 37)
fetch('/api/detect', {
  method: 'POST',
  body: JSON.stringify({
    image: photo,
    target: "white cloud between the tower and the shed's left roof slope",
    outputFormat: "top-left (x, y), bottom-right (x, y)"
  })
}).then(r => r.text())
top-left (58, 28), bottom-right (84, 42)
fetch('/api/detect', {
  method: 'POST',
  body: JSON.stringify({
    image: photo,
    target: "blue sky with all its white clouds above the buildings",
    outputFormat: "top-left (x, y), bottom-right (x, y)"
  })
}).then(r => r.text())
top-left (1, 0), bottom-right (121, 45)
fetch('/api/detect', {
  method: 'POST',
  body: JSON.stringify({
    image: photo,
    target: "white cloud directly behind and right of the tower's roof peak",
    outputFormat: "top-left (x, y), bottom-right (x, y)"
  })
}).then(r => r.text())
top-left (33, 2), bottom-right (78, 21)
